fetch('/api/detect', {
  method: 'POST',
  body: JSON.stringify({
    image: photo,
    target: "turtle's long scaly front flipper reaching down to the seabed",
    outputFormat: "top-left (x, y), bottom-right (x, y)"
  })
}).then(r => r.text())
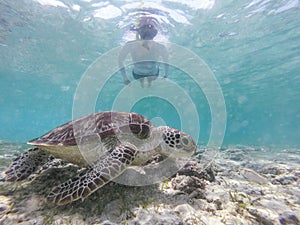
top-left (48, 144), bottom-right (137, 205)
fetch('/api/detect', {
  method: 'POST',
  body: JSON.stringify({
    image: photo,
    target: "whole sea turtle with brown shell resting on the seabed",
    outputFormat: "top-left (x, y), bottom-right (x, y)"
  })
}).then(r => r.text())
top-left (5, 111), bottom-right (196, 205)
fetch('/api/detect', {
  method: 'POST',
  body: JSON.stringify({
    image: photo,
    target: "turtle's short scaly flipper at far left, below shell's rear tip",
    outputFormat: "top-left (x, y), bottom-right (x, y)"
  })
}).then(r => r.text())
top-left (4, 148), bottom-right (49, 181)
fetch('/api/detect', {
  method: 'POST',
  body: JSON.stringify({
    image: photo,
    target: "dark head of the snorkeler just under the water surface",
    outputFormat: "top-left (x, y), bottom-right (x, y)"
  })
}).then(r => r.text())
top-left (136, 17), bottom-right (158, 40)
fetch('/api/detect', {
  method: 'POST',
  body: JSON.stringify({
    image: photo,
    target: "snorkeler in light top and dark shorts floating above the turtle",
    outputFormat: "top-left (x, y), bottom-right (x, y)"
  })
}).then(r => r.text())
top-left (119, 17), bottom-right (168, 87)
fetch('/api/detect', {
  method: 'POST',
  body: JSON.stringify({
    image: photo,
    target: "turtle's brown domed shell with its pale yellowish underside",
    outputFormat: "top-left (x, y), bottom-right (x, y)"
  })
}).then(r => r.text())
top-left (28, 111), bottom-right (153, 164)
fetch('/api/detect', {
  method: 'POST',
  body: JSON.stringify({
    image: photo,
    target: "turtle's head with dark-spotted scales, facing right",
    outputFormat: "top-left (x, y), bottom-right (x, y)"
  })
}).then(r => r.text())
top-left (157, 126), bottom-right (197, 158)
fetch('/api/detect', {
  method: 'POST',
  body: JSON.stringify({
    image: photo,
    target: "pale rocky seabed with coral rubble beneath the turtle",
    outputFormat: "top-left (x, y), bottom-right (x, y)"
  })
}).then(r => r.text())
top-left (0, 143), bottom-right (300, 225)
